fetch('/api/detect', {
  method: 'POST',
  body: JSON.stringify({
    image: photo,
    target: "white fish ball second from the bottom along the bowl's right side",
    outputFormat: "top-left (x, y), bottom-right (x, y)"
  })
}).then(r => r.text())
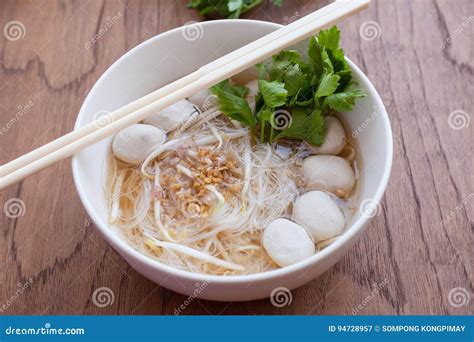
top-left (293, 191), bottom-right (346, 242)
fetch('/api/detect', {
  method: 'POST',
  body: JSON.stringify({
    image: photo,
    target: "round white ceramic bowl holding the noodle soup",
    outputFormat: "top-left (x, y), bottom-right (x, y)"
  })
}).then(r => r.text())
top-left (72, 20), bottom-right (393, 301)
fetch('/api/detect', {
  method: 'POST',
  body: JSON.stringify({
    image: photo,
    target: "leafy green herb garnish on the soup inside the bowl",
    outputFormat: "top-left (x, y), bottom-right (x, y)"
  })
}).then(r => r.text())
top-left (211, 26), bottom-right (365, 146)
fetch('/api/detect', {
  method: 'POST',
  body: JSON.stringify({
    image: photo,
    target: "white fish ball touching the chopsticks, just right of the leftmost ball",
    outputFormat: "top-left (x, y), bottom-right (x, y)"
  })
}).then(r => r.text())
top-left (143, 100), bottom-right (196, 132)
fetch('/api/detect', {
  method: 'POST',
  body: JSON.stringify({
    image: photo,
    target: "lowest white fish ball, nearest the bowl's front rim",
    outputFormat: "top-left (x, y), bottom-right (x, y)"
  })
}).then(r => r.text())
top-left (262, 218), bottom-right (316, 267)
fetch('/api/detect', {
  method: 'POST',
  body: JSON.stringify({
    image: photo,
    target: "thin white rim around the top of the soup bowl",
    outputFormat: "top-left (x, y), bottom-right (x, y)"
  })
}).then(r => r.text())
top-left (71, 19), bottom-right (393, 284)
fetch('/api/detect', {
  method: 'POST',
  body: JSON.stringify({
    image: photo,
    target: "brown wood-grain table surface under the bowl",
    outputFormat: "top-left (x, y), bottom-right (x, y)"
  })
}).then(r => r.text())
top-left (0, 0), bottom-right (474, 315)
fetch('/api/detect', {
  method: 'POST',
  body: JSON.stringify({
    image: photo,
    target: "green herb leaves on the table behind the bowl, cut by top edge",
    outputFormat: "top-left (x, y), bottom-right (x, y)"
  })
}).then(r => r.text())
top-left (188, 0), bottom-right (283, 19)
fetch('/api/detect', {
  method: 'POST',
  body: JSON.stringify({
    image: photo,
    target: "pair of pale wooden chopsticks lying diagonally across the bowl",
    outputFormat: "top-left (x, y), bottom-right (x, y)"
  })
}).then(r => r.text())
top-left (0, 0), bottom-right (370, 189)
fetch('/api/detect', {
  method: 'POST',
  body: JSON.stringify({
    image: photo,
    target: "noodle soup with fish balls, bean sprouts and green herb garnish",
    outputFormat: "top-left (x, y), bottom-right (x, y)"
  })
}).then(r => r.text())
top-left (107, 28), bottom-right (363, 275)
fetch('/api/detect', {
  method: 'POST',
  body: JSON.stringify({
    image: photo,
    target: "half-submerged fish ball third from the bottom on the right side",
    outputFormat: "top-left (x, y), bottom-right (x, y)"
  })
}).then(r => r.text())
top-left (303, 155), bottom-right (355, 197)
